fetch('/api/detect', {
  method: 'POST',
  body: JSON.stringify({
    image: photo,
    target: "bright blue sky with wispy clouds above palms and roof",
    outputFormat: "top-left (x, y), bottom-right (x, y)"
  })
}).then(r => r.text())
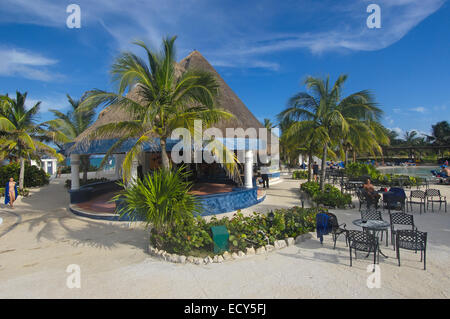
top-left (0, 0), bottom-right (450, 139)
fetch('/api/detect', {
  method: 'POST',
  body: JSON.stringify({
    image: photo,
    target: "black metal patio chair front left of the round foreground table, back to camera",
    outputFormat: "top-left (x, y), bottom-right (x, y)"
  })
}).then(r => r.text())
top-left (346, 230), bottom-right (380, 271)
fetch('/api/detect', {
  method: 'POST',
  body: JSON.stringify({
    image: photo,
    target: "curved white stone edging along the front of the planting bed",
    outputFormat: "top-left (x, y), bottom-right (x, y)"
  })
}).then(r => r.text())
top-left (149, 233), bottom-right (312, 265)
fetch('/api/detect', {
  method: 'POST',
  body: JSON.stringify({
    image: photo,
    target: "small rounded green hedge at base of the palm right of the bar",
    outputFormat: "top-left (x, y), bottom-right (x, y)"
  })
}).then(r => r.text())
top-left (300, 182), bottom-right (352, 208)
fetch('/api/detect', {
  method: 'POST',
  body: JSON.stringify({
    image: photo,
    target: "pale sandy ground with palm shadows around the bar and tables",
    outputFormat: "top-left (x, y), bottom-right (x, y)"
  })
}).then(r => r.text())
top-left (0, 178), bottom-right (450, 298)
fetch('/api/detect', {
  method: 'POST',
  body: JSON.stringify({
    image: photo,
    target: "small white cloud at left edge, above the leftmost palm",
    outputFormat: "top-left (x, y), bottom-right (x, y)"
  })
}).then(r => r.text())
top-left (0, 48), bottom-right (58, 81)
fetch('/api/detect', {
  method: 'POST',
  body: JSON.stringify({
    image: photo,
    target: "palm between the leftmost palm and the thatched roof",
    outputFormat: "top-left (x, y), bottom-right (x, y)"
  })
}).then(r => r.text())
top-left (42, 94), bottom-right (95, 183)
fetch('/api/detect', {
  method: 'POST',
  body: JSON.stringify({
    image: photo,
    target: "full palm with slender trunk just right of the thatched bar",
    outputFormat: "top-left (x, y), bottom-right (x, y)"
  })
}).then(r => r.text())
top-left (280, 75), bottom-right (382, 190)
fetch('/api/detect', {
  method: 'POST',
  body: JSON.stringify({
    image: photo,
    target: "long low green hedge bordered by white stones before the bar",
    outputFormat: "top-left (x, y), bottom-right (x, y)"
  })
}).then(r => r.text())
top-left (150, 207), bottom-right (326, 256)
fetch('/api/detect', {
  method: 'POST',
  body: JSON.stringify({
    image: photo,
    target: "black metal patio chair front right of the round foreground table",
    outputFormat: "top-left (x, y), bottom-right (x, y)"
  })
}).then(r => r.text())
top-left (395, 230), bottom-right (427, 270)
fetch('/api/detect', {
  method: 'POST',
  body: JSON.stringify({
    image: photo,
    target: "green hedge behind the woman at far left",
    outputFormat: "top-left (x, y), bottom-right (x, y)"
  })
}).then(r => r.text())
top-left (0, 163), bottom-right (50, 187)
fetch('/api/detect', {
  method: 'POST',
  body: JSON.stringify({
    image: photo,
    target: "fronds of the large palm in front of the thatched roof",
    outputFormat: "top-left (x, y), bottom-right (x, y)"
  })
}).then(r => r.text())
top-left (82, 36), bottom-right (237, 179)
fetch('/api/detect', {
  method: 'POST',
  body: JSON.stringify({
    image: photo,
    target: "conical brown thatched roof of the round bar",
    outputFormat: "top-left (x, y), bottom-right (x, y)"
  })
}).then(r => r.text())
top-left (75, 51), bottom-right (270, 154)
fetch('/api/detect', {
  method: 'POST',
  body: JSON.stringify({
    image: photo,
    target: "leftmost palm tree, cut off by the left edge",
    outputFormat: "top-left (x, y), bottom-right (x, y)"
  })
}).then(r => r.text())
top-left (0, 92), bottom-right (62, 190)
